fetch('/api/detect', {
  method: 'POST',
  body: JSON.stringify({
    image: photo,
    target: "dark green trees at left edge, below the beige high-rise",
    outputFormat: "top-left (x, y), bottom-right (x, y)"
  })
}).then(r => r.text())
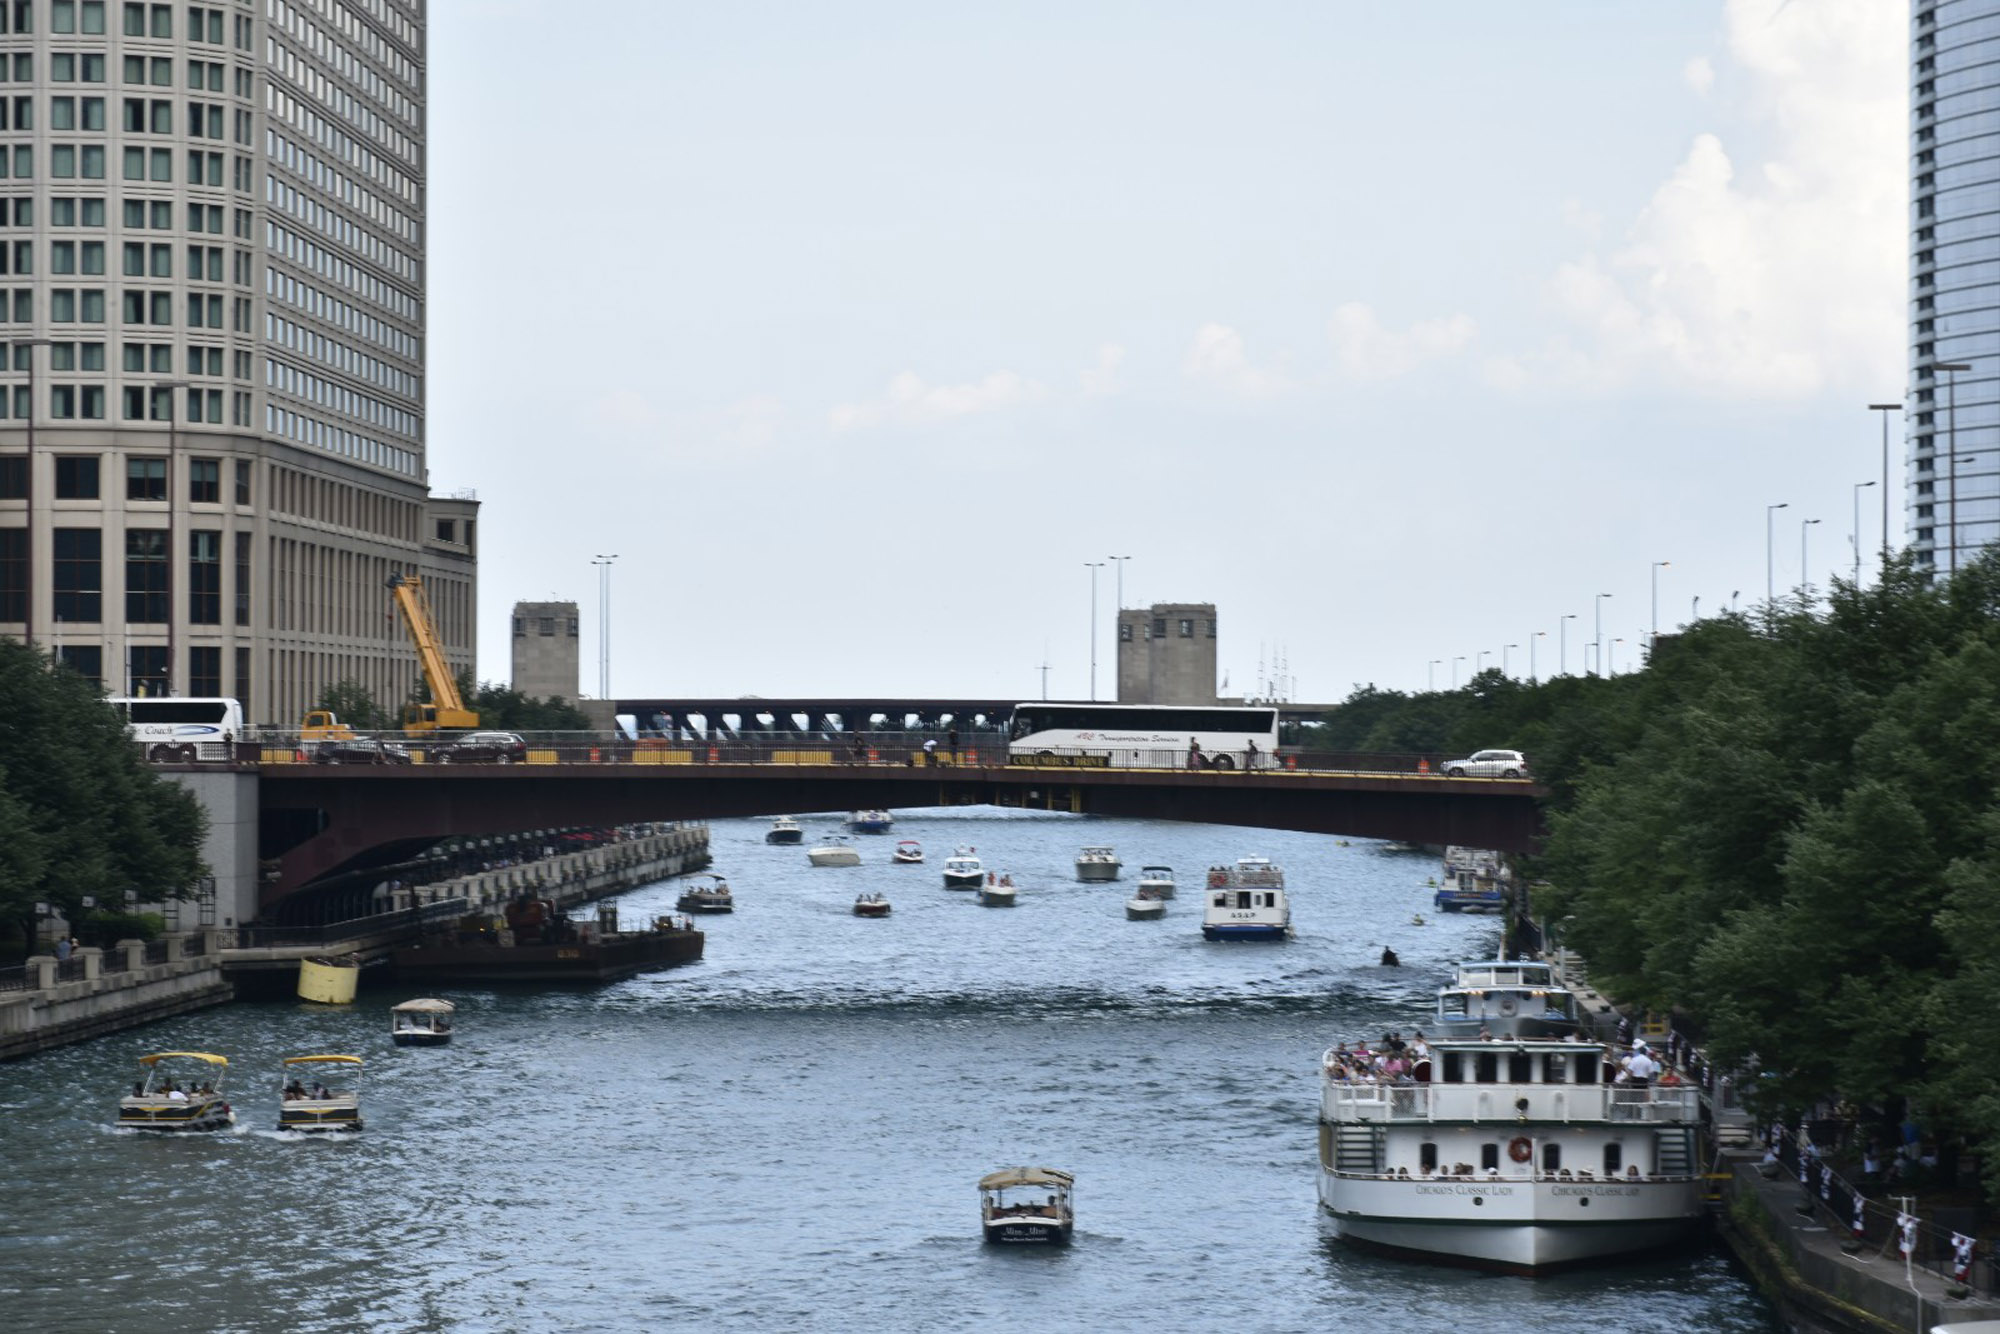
top-left (0, 640), bottom-right (208, 956)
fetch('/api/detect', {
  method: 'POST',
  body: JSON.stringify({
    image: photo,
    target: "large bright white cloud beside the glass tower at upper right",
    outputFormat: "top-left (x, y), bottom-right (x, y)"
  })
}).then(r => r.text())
top-left (1486, 0), bottom-right (1908, 398)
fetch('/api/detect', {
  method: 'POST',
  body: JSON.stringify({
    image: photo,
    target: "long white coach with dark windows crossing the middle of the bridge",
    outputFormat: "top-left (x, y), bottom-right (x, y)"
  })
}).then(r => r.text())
top-left (1008, 704), bottom-right (1278, 768)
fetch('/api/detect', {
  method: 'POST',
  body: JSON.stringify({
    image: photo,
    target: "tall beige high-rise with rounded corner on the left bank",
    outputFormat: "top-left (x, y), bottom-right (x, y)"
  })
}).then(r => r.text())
top-left (0, 0), bottom-right (478, 722)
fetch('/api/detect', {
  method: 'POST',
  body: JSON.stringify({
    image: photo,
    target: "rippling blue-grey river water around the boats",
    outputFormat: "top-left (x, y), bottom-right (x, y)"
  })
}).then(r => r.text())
top-left (0, 808), bottom-right (1780, 1334)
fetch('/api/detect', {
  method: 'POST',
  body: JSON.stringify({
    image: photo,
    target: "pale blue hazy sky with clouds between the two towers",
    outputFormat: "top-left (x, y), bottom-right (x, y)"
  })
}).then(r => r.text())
top-left (428, 0), bottom-right (1908, 702)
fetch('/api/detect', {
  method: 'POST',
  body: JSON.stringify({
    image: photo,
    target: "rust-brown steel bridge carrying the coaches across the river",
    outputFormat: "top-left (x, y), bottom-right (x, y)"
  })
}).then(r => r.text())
top-left (238, 738), bottom-right (1546, 908)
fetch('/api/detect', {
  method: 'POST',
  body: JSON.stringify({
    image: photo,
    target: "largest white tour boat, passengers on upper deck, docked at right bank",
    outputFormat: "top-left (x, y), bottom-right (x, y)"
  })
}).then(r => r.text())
top-left (1320, 1038), bottom-right (1702, 1274)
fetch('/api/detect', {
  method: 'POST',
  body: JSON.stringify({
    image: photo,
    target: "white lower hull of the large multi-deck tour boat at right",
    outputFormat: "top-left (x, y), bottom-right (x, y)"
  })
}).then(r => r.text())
top-left (1320, 1170), bottom-right (1702, 1274)
